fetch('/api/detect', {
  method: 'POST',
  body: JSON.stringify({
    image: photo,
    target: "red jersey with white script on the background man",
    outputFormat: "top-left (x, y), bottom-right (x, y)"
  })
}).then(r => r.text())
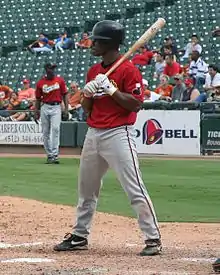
top-left (35, 76), bottom-right (67, 103)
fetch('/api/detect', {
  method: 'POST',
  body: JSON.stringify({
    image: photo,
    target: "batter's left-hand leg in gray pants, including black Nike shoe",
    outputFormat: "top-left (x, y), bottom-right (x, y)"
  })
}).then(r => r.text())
top-left (54, 129), bottom-right (108, 251)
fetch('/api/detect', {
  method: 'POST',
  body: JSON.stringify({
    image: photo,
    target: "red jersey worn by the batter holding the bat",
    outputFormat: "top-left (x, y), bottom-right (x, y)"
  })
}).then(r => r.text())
top-left (87, 60), bottom-right (144, 129)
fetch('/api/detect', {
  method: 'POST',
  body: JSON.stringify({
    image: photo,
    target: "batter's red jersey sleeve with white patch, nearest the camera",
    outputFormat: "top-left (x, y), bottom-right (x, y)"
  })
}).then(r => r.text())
top-left (121, 67), bottom-right (144, 102)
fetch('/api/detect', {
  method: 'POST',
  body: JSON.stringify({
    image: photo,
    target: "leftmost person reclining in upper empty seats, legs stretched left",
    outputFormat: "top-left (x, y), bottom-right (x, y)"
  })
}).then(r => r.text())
top-left (27, 33), bottom-right (54, 53)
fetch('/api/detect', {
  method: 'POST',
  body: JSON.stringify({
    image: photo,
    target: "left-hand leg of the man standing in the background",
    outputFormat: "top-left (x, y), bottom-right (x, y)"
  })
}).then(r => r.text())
top-left (40, 104), bottom-right (53, 164)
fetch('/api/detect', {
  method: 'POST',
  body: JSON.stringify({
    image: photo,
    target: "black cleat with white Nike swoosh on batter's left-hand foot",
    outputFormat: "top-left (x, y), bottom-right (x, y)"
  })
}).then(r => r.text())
top-left (53, 233), bottom-right (88, 251)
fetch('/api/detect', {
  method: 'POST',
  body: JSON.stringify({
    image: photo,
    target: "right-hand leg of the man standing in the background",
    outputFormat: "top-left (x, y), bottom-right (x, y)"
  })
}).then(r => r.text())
top-left (51, 105), bottom-right (61, 164)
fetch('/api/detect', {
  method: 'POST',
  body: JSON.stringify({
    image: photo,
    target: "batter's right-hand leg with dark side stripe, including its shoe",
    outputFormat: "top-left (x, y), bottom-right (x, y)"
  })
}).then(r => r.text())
top-left (101, 126), bottom-right (161, 255)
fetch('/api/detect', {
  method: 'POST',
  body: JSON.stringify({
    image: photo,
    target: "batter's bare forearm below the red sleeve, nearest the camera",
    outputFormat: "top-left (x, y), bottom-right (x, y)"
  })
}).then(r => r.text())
top-left (112, 91), bottom-right (142, 112)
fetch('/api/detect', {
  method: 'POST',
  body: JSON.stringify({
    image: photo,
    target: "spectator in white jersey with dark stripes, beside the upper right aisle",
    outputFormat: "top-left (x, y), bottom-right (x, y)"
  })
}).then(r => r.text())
top-left (189, 51), bottom-right (208, 91)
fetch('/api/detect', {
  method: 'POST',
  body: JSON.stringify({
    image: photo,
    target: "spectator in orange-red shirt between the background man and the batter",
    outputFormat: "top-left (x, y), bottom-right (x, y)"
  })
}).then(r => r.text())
top-left (68, 82), bottom-right (84, 121)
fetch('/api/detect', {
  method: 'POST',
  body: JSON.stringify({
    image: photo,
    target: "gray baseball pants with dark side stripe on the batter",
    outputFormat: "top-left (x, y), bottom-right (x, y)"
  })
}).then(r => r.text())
top-left (73, 126), bottom-right (160, 243)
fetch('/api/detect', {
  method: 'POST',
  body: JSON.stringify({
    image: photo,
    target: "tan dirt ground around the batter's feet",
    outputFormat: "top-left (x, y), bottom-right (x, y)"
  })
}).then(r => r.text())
top-left (0, 197), bottom-right (220, 275)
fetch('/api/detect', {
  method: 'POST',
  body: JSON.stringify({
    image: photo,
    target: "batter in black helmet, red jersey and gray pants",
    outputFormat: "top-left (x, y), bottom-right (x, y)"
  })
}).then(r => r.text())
top-left (54, 20), bottom-right (161, 256)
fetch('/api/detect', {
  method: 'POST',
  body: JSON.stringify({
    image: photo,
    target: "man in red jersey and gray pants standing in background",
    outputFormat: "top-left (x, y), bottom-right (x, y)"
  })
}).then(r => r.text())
top-left (35, 63), bottom-right (68, 164)
